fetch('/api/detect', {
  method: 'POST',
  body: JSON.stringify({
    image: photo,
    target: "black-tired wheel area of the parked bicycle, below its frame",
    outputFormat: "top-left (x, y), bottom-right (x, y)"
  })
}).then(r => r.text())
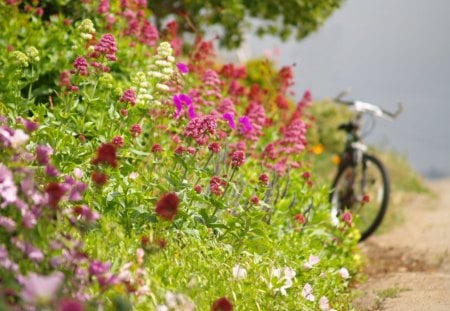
top-left (330, 154), bottom-right (390, 241)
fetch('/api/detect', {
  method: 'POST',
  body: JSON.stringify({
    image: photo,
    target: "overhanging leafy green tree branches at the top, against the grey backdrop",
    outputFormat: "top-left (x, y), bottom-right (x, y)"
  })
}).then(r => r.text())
top-left (148, 0), bottom-right (342, 48)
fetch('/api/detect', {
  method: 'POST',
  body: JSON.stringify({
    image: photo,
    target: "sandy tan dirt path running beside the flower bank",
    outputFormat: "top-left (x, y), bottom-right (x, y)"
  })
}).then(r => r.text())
top-left (355, 179), bottom-right (450, 311)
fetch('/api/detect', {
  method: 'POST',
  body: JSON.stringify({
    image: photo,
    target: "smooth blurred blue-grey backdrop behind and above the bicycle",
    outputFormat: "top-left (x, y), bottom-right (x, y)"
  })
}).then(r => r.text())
top-left (242, 0), bottom-right (450, 178)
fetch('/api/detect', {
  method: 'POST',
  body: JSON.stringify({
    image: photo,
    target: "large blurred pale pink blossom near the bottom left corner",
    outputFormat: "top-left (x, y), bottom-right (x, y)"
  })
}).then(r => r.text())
top-left (21, 271), bottom-right (64, 305)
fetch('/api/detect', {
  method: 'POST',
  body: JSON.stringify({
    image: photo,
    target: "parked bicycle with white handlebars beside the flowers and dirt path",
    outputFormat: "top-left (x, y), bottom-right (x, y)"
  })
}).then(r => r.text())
top-left (330, 92), bottom-right (403, 241)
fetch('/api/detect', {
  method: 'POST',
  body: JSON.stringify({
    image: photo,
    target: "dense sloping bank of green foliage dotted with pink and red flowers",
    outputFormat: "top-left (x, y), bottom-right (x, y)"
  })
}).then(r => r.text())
top-left (0, 1), bottom-right (361, 310)
